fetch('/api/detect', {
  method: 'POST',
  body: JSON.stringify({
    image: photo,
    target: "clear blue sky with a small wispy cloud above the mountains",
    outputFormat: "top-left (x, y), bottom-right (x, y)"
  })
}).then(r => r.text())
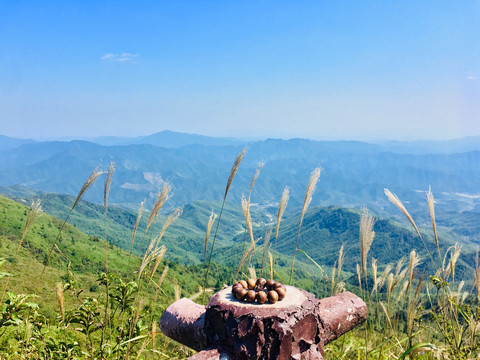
top-left (0, 0), bottom-right (480, 140)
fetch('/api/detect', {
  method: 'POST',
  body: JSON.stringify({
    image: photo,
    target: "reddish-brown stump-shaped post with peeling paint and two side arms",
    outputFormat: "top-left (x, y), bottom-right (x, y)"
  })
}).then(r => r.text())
top-left (159, 286), bottom-right (367, 360)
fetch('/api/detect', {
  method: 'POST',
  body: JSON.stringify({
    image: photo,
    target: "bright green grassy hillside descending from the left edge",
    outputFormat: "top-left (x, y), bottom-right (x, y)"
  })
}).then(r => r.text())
top-left (0, 196), bottom-right (200, 315)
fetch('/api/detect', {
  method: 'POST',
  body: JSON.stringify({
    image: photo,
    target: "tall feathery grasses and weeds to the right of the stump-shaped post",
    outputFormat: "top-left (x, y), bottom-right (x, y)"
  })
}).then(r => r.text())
top-left (326, 189), bottom-right (480, 359)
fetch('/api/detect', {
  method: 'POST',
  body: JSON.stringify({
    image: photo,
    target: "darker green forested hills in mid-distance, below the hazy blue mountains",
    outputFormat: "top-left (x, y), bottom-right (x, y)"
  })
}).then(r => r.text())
top-left (3, 190), bottom-right (475, 286)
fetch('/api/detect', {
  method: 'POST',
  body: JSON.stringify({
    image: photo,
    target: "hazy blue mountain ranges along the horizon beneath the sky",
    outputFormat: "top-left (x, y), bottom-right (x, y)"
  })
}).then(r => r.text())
top-left (0, 132), bottom-right (480, 236)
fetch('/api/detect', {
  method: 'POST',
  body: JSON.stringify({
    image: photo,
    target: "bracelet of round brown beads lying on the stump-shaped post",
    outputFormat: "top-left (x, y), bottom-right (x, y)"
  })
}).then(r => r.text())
top-left (232, 278), bottom-right (287, 304)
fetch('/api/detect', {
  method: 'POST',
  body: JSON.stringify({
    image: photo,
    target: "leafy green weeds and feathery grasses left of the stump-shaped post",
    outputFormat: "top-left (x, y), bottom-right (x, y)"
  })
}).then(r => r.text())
top-left (0, 162), bottom-right (192, 359)
